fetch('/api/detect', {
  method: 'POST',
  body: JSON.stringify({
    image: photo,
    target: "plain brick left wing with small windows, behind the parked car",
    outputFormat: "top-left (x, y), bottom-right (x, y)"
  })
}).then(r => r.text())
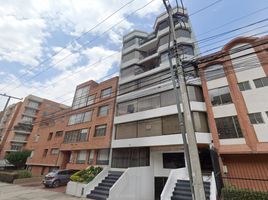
top-left (26, 99), bottom-right (70, 176)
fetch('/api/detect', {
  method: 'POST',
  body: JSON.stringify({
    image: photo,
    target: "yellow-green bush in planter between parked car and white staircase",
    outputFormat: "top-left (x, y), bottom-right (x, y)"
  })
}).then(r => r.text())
top-left (70, 166), bottom-right (102, 183)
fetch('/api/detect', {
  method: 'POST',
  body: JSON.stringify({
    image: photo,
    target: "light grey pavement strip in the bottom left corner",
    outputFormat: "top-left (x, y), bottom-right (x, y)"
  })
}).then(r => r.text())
top-left (0, 182), bottom-right (85, 200)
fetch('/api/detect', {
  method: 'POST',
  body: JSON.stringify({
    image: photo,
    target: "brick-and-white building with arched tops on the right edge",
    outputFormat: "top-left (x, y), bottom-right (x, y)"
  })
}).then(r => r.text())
top-left (199, 36), bottom-right (268, 189)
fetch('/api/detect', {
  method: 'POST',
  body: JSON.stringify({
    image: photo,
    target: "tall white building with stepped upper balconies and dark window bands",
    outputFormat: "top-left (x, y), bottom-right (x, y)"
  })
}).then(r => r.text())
top-left (108, 8), bottom-right (211, 199)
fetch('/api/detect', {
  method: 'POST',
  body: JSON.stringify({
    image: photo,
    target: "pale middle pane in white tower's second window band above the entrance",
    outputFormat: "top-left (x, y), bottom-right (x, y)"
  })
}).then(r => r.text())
top-left (138, 94), bottom-right (160, 111)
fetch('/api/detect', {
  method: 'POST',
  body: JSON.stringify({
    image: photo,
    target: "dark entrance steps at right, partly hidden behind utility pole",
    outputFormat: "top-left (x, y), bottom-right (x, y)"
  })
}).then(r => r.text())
top-left (171, 180), bottom-right (210, 200)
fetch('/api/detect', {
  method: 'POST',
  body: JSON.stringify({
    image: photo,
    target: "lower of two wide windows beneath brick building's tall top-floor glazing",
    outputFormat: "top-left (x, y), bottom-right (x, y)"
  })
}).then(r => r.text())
top-left (63, 129), bottom-right (89, 143)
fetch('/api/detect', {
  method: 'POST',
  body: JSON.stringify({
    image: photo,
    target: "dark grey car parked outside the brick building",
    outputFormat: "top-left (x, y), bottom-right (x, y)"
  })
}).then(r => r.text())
top-left (43, 170), bottom-right (77, 188)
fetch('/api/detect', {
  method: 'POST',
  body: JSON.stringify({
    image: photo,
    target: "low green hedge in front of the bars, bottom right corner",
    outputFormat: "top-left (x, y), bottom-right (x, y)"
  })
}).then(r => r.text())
top-left (222, 186), bottom-right (268, 200)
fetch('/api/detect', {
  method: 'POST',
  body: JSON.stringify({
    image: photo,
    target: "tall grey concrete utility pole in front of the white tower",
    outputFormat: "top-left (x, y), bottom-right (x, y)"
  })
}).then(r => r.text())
top-left (163, 0), bottom-right (206, 200)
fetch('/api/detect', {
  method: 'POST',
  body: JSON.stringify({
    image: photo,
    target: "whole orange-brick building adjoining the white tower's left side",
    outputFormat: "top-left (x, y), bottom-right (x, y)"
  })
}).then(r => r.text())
top-left (26, 77), bottom-right (118, 175)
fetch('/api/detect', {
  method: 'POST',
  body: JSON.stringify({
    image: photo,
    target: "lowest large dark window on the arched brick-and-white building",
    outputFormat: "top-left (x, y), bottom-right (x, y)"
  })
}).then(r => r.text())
top-left (215, 116), bottom-right (243, 139)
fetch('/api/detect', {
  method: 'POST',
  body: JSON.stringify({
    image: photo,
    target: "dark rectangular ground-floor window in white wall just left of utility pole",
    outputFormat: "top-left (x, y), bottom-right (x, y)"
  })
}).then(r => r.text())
top-left (163, 153), bottom-right (185, 169)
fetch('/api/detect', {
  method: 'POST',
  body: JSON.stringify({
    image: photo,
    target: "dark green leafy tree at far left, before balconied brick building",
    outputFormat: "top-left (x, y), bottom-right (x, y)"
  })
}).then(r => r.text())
top-left (6, 150), bottom-right (31, 168)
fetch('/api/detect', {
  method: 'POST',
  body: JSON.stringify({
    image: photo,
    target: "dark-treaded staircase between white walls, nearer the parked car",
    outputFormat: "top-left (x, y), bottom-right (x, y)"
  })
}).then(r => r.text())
top-left (87, 171), bottom-right (123, 200)
